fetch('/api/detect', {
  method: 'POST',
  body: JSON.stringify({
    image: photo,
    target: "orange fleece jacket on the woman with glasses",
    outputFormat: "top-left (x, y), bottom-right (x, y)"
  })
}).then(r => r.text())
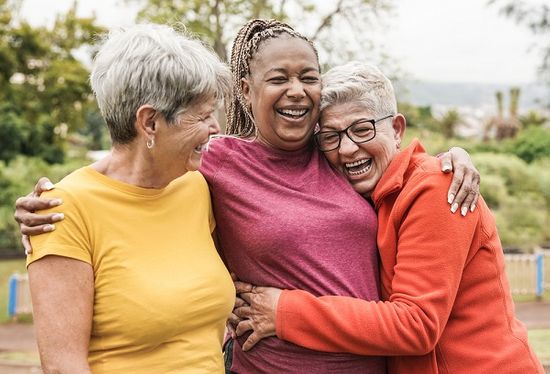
top-left (276, 140), bottom-right (543, 374)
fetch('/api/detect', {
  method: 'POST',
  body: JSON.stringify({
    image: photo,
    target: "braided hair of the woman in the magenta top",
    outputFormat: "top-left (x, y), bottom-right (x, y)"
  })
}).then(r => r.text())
top-left (226, 19), bottom-right (319, 138)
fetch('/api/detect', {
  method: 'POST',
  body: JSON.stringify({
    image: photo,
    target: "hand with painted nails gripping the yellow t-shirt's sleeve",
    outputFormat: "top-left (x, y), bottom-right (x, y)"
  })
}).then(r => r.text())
top-left (14, 177), bottom-right (65, 254)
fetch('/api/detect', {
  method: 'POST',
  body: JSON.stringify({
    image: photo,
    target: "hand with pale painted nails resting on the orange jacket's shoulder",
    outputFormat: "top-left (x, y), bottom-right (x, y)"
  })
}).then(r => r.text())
top-left (439, 147), bottom-right (481, 216)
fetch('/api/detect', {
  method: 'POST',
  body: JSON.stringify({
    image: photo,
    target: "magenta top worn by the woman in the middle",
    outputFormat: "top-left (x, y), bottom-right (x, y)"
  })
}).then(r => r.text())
top-left (201, 137), bottom-right (385, 374)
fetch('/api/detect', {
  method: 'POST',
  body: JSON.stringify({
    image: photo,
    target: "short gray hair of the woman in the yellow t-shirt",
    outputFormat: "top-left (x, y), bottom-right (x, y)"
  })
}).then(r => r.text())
top-left (90, 24), bottom-right (231, 144)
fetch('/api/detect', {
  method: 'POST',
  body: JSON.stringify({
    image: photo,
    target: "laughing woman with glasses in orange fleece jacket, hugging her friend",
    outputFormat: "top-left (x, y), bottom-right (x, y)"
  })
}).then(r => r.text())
top-left (235, 62), bottom-right (543, 374)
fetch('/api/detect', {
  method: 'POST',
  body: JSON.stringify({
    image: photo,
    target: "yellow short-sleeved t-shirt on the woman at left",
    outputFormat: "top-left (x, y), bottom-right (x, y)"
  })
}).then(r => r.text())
top-left (27, 166), bottom-right (235, 374)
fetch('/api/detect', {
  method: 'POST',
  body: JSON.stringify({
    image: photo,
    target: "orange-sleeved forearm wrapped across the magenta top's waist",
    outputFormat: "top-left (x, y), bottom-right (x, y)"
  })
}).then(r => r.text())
top-left (276, 291), bottom-right (443, 356)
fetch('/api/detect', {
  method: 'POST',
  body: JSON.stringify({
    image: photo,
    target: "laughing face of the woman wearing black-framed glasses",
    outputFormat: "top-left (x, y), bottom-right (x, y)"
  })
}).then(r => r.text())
top-left (320, 102), bottom-right (405, 197)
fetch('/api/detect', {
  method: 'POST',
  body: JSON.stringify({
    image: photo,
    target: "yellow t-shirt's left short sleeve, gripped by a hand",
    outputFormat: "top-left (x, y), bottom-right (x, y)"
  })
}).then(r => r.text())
top-left (27, 188), bottom-right (92, 266)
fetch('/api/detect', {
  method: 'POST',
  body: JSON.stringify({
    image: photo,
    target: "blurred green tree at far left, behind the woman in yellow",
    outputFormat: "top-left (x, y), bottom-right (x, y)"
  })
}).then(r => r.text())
top-left (0, 0), bottom-right (104, 162)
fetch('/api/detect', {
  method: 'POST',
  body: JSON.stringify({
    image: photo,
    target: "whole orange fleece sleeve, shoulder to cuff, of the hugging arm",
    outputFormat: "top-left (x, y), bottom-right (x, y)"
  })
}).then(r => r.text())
top-left (276, 172), bottom-right (479, 356)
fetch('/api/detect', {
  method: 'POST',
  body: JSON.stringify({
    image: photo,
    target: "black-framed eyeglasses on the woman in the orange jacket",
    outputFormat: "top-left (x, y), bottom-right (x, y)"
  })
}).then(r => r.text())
top-left (315, 114), bottom-right (394, 152)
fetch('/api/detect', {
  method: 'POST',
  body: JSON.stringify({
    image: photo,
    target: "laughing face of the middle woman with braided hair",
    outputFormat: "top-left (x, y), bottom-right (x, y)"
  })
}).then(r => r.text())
top-left (242, 34), bottom-right (321, 150)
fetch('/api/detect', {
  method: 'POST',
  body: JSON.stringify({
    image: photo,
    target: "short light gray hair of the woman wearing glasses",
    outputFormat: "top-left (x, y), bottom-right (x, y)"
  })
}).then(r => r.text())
top-left (321, 61), bottom-right (397, 116)
